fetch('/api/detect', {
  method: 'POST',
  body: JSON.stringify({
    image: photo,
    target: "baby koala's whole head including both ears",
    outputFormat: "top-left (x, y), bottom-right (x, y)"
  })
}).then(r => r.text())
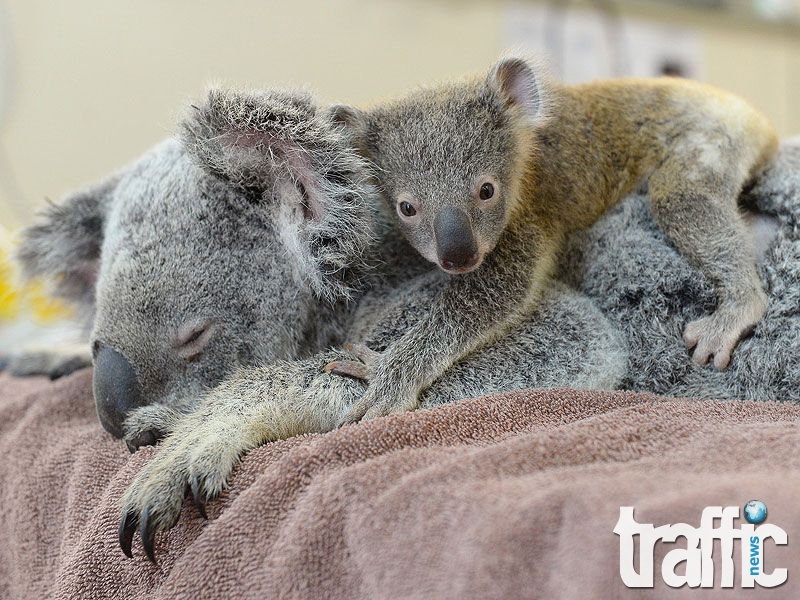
top-left (330, 57), bottom-right (547, 274)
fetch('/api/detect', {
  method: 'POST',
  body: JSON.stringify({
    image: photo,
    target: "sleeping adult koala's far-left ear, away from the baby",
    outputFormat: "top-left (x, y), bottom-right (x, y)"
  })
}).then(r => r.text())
top-left (16, 176), bottom-right (119, 311)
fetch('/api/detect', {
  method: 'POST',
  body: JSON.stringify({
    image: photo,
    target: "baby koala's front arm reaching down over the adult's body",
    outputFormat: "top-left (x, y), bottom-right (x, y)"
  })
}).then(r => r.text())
top-left (327, 222), bottom-right (558, 423)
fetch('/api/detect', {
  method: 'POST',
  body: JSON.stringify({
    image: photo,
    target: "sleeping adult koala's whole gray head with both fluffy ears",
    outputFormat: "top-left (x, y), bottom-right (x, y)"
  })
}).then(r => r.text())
top-left (19, 91), bottom-right (374, 437)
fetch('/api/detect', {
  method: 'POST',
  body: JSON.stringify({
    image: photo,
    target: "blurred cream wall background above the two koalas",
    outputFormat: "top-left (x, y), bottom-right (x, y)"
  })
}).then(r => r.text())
top-left (0, 0), bottom-right (800, 346)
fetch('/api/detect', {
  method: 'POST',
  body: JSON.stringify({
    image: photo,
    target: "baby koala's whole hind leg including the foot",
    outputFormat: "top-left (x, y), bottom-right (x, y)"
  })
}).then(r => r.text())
top-left (650, 154), bottom-right (767, 370)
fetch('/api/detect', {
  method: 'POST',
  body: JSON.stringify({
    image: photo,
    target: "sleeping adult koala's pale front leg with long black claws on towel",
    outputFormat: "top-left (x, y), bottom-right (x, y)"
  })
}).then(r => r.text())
top-left (119, 352), bottom-right (364, 561)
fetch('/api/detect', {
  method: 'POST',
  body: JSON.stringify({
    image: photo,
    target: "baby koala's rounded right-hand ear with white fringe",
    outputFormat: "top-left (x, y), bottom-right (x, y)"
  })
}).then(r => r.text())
top-left (487, 57), bottom-right (546, 120)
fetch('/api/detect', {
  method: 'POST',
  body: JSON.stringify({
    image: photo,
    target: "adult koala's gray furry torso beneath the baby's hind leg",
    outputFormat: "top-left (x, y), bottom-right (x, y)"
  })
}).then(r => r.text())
top-left (559, 138), bottom-right (800, 401)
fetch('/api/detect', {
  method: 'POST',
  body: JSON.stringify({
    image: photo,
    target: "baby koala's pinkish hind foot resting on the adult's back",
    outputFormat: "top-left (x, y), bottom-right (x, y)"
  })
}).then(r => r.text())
top-left (683, 290), bottom-right (767, 370)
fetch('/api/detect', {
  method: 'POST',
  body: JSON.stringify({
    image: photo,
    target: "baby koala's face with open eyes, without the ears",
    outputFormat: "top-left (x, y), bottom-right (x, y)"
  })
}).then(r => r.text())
top-left (370, 87), bottom-right (520, 274)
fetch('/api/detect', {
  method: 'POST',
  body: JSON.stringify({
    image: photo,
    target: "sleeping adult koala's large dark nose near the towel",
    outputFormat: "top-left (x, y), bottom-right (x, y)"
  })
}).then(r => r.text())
top-left (93, 345), bottom-right (142, 438)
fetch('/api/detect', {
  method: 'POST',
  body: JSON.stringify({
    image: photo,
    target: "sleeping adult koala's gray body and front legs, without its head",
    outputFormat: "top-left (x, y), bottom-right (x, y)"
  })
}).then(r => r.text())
top-left (120, 140), bottom-right (800, 559)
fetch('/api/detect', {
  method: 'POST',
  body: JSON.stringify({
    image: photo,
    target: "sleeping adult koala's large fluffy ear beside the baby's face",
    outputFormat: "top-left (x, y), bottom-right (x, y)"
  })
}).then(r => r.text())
top-left (182, 90), bottom-right (376, 300)
